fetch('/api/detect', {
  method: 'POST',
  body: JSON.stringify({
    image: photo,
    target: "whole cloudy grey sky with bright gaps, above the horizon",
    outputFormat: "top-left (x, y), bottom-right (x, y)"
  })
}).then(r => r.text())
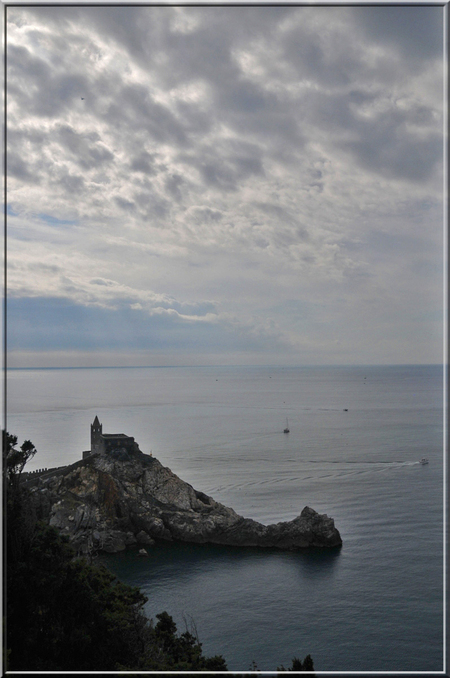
top-left (6, 5), bottom-right (444, 366)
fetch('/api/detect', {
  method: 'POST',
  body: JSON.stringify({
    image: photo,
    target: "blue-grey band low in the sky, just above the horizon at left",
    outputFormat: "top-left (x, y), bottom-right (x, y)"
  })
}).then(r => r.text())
top-left (8, 297), bottom-right (296, 362)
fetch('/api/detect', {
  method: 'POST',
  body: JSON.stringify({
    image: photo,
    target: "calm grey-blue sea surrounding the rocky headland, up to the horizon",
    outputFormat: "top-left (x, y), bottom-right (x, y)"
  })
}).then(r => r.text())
top-left (6, 365), bottom-right (446, 673)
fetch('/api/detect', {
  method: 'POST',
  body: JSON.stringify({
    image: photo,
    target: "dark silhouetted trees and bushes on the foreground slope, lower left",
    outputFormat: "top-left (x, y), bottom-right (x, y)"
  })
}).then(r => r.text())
top-left (3, 431), bottom-right (314, 675)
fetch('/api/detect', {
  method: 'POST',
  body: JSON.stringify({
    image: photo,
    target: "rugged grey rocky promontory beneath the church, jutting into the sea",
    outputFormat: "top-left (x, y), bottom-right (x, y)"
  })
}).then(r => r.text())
top-left (30, 451), bottom-right (342, 553)
